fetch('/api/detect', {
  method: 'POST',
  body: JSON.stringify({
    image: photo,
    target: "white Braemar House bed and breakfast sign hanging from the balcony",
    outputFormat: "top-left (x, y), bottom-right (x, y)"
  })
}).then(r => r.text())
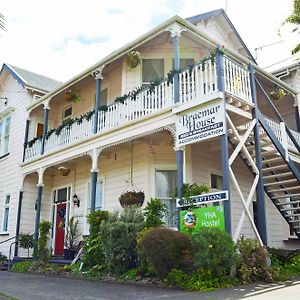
top-left (176, 99), bottom-right (225, 147)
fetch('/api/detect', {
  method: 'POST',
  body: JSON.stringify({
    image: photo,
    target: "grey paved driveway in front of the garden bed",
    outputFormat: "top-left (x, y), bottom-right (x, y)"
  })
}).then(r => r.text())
top-left (0, 271), bottom-right (300, 300)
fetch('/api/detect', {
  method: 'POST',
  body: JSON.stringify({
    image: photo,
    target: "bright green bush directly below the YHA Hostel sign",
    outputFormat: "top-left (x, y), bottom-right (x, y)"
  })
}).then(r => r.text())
top-left (192, 228), bottom-right (237, 277)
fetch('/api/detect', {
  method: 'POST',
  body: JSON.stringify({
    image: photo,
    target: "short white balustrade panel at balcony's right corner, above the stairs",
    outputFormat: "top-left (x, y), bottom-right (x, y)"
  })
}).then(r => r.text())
top-left (224, 56), bottom-right (252, 102)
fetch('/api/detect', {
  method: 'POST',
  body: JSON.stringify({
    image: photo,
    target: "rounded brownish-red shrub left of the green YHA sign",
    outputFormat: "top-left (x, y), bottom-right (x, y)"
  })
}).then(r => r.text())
top-left (139, 228), bottom-right (194, 278)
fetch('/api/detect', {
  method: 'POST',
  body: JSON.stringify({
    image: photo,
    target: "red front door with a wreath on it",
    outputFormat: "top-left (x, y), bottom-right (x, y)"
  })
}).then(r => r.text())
top-left (54, 203), bottom-right (66, 255)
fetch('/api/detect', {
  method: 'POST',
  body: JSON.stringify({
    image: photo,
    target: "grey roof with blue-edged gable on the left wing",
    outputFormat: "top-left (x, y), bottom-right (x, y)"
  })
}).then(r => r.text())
top-left (0, 64), bottom-right (62, 92)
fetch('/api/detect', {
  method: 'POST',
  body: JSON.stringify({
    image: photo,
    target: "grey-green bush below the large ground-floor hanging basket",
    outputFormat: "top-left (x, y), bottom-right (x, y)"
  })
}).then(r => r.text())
top-left (100, 208), bottom-right (145, 275)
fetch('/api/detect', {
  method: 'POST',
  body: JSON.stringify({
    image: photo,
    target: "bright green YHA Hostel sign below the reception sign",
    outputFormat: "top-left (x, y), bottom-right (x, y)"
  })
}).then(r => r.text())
top-left (180, 205), bottom-right (225, 233)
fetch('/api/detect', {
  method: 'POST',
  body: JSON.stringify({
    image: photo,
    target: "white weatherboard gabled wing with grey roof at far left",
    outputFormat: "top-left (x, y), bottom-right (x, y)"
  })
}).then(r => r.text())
top-left (0, 64), bottom-right (61, 255)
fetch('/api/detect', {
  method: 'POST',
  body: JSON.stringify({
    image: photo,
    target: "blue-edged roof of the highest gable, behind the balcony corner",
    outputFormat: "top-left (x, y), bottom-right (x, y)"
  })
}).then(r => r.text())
top-left (186, 8), bottom-right (255, 62)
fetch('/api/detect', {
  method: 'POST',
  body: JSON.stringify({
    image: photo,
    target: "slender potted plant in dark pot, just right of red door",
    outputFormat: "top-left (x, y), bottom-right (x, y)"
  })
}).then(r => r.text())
top-left (64, 217), bottom-right (79, 259)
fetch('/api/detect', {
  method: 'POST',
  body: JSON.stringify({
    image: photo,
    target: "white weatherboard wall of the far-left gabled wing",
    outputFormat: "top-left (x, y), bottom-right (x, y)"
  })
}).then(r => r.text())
top-left (0, 71), bottom-right (30, 255)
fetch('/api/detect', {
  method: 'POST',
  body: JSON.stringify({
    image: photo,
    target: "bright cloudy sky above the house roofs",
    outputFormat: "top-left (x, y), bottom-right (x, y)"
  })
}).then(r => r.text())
top-left (0, 0), bottom-right (299, 81)
